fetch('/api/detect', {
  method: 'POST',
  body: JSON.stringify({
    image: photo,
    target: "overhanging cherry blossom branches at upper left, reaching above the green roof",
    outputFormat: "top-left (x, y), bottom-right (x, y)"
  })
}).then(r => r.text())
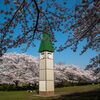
top-left (0, 0), bottom-right (68, 56)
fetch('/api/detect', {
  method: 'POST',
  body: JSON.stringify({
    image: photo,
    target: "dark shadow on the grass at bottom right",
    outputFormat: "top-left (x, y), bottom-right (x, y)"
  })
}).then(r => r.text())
top-left (54, 89), bottom-right (100, 100)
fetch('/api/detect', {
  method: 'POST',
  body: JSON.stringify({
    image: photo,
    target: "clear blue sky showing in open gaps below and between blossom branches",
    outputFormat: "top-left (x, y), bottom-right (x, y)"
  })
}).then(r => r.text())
top-left (1, 0), bottom-right (97, 68)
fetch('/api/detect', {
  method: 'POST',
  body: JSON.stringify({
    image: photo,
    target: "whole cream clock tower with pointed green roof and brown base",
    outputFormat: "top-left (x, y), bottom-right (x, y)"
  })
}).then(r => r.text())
top-left (39, 31), bottom-right (54, 96)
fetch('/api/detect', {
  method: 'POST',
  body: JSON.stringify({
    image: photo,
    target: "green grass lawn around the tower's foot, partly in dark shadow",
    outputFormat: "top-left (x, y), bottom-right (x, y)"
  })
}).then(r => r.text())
top-left (0, 84), bottom-right (100, 100)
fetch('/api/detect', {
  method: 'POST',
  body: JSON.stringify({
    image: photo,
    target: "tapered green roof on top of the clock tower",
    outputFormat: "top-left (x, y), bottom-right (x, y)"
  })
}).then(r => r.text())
top-left (39, 32), bottom-right (54, 52)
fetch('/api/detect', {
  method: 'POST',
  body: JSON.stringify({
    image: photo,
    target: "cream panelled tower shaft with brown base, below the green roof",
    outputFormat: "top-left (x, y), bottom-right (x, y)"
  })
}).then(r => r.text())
top-left (39, 51), bottom-right (54, 95)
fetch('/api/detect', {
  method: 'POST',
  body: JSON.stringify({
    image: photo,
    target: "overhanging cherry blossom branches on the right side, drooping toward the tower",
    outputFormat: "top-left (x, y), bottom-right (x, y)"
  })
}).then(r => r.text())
top-left (58, 0), bottom-right (100, 67)
